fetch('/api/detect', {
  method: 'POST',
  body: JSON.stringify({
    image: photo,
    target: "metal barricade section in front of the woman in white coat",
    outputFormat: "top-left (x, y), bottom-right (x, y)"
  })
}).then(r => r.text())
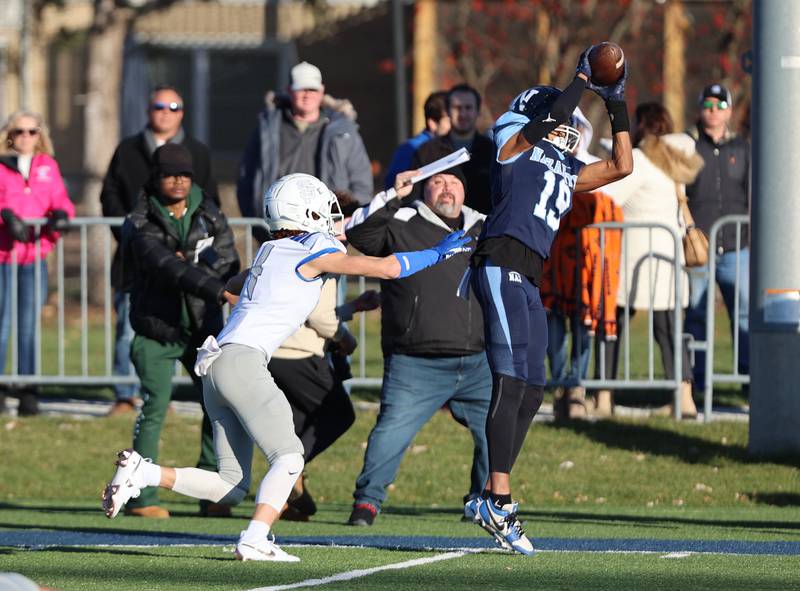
top-left (551, 222), bottom-right (683, 419)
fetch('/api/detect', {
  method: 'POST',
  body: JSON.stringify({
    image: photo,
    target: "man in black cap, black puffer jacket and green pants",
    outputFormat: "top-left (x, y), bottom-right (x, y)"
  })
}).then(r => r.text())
top-left (122, 143), bottom-right (239, 518)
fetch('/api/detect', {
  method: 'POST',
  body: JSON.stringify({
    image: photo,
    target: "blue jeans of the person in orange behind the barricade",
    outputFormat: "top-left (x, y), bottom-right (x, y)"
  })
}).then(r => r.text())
top-left (547, 310), bottom-right (590, 385)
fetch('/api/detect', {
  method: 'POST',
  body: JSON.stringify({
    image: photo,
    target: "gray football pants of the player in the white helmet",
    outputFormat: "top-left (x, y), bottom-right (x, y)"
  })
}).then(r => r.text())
top-left (203, 344), bottom-right (303, 502)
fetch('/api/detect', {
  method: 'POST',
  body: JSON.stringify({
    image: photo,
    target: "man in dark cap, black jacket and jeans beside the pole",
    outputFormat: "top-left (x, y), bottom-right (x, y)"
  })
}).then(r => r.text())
top-left (685, 84), bottom-right (750, 391)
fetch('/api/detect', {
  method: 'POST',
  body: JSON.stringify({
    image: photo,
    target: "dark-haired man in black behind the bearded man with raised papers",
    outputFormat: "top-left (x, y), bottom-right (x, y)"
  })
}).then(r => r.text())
top-left (411, 84), bottom-right (494, 214)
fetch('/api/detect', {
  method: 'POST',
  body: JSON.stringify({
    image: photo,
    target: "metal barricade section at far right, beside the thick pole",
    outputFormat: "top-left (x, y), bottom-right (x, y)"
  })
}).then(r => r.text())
top-left (695, 215), bottom-right (750, 423)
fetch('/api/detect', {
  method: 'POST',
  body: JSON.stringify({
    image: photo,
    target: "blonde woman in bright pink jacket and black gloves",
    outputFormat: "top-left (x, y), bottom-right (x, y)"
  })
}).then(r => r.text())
top-left (0, 111), bottom-right (75, 416)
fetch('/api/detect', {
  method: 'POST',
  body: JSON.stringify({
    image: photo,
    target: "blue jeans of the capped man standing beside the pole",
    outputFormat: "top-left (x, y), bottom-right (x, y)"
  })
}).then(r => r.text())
top-left (684, 248), bottom-right (750, 390)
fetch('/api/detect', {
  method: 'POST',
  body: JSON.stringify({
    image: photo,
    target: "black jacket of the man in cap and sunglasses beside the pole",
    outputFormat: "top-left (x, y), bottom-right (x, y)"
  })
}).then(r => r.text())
top-left (686, 126), bottom-right (750, 251)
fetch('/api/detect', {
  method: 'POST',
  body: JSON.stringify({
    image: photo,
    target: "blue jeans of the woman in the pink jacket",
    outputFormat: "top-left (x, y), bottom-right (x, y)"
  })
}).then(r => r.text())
top-left (0, 260), bottom-right (47, 375)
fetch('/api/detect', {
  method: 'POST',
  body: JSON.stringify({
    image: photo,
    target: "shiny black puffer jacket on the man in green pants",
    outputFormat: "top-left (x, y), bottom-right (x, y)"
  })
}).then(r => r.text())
top-left (121, 193), bottom-right (239, 343)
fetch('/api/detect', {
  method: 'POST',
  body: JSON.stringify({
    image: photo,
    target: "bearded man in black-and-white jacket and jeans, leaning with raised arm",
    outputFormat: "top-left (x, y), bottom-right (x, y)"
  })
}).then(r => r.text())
top-left (347, 168), bottom-right (492, 525)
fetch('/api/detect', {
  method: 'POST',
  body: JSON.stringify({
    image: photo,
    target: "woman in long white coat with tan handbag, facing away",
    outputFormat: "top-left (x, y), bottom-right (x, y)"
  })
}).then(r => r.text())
top-left (604, 103), bottom-right (703, 417)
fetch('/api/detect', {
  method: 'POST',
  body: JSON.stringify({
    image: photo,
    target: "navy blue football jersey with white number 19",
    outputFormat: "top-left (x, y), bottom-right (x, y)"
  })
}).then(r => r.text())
top-left (479, 140), bottom-right (583, 259)
